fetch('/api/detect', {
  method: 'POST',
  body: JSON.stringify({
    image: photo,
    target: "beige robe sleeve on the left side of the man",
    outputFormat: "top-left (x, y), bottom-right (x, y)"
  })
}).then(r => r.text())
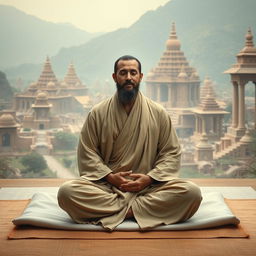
top-left (77, 112), bottom-right (112, 181)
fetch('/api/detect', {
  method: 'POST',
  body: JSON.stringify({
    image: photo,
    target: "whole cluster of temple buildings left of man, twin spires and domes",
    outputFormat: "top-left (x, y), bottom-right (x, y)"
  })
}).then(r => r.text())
top-left (0, 57), bottom-right (92, 153)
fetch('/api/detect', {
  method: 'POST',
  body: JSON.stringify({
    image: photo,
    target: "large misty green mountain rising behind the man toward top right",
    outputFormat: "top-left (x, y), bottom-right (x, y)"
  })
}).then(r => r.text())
top-left (3, 0), bottom-right (256, 92)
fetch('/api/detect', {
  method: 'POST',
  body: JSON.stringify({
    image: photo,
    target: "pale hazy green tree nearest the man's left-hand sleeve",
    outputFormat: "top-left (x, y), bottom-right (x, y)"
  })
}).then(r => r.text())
top-left (55, 132), bottom-right (78, 150)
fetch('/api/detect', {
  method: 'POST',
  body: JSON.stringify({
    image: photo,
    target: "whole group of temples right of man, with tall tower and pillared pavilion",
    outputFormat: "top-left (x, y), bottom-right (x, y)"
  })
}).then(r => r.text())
top-left (146, 23), bottom-right (256, 174)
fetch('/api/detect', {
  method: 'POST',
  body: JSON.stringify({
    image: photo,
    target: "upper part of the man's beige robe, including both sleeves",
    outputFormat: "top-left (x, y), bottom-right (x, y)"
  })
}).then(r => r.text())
top-left (78, 92), bottom-right (181, 181)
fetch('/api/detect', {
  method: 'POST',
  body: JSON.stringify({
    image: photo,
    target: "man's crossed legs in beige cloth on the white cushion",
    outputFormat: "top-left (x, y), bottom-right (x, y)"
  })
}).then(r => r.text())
top-left (58, 177), bottom-right (201, 228)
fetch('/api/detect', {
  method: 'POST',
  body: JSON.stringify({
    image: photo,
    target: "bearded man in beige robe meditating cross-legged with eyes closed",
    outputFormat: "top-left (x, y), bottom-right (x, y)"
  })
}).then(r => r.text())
top-left (58, 55), bottom-right (201, 230)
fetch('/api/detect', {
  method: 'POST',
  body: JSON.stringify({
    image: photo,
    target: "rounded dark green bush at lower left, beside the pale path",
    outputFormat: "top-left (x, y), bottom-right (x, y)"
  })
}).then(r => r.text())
top-left (21, 152), bottom-right (48, 173)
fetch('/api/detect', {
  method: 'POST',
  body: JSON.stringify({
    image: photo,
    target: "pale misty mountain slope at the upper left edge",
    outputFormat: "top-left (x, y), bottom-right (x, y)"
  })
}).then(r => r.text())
top-left (0, 5), bottom-right (99, 69)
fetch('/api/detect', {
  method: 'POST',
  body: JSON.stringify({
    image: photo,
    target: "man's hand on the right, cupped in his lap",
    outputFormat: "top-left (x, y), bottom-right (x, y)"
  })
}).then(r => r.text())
top-left (119, 173), bottom-right (153, 192)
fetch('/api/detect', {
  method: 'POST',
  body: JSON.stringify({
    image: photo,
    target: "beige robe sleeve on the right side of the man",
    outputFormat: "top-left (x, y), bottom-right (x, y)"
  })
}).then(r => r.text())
top-left (148, 110), bottom-right (181, 181)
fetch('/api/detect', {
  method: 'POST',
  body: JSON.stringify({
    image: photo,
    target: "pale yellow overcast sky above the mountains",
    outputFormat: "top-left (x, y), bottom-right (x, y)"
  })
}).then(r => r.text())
top-left (0, 0), bottom-right (169, 32)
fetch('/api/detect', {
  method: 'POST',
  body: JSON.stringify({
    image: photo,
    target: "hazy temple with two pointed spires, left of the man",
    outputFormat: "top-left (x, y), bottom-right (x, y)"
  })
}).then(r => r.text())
top-left (14, 57), bottom-right (90, 114)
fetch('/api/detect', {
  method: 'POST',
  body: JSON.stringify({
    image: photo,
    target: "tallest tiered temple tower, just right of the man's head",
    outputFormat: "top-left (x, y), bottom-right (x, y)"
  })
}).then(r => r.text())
top-left (146, 23), bottom-right (200, 108)
